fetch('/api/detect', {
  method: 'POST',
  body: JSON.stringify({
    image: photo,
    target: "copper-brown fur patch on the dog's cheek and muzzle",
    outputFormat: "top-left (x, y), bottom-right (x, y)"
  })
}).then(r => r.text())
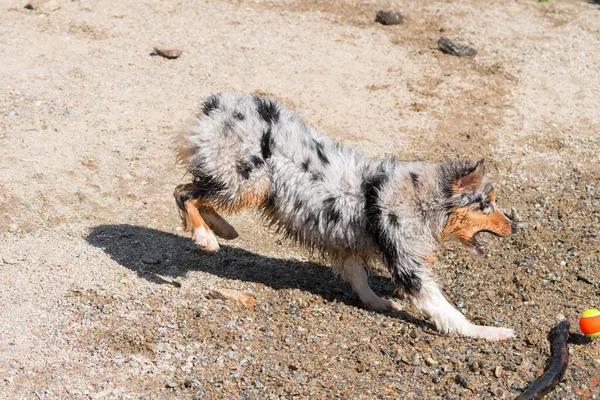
top-left (440, 207), bottom-right (512, 246)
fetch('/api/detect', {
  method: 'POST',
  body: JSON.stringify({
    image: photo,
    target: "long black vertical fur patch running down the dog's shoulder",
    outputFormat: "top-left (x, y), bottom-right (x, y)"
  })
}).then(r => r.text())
top-left (363, 174), bottom-right (422, 295)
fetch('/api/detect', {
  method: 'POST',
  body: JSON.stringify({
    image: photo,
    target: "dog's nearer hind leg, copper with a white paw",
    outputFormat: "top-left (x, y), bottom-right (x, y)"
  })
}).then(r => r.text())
top-left (173, 183), bottom-right (221, 252)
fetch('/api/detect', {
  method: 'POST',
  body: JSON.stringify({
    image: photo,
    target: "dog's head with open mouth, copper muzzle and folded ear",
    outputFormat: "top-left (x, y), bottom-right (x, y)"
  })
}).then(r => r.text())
top-left (440, 160), bottom-right (516, 257)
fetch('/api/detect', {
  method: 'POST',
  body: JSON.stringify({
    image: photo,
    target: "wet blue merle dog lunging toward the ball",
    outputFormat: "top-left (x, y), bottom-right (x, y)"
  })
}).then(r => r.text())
top-left (174, 93), bottom-right (516, 340)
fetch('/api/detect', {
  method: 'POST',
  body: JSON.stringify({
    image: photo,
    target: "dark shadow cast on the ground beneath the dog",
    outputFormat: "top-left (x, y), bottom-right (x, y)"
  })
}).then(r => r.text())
top-left (85, 224), bottom-right (432, 329)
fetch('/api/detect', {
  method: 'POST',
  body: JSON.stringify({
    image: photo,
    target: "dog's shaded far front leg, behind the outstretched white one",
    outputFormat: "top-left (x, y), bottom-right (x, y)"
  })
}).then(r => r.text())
top-left (342, 256), bottom-right (400, 311)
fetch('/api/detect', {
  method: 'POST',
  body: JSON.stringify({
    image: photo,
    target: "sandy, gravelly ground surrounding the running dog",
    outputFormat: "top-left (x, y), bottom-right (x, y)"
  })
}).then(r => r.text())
top-left (0, 0), bottom-right (600, 399)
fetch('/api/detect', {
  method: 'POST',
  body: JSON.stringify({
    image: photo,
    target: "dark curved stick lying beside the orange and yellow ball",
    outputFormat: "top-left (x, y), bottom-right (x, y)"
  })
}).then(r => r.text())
top-left (515, 321), bottom-right (569, 400)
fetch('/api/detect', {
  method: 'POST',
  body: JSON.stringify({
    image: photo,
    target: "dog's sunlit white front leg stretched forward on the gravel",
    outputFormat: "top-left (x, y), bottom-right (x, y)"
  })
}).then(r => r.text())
top-left (409, 273), bottom-right (515, 340)
